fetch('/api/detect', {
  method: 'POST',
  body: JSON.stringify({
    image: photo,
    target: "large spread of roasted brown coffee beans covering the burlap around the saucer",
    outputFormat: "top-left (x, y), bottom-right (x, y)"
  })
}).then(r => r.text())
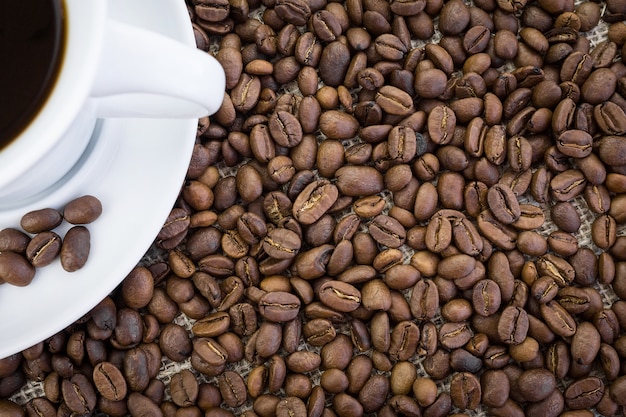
top-left (0, 0), bottom-right (626, 417)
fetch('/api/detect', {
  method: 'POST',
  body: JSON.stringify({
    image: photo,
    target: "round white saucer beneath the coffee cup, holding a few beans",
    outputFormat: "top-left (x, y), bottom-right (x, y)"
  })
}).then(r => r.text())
top-left (0, 0), bottom-right (197, 358)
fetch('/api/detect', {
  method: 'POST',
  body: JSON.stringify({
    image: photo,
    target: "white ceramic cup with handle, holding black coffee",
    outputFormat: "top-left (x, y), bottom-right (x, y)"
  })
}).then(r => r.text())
top-left (0, 0), bottom-right (225, 204)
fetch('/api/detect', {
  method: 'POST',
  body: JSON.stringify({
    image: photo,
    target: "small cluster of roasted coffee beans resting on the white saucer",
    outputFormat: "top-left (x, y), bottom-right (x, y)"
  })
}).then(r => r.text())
top-left (0, 195), bottom-right (102, 287)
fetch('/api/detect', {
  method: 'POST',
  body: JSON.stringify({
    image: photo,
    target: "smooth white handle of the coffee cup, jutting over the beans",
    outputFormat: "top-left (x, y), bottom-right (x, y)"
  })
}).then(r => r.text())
top-left (90, 20), bottom-right (226, 118)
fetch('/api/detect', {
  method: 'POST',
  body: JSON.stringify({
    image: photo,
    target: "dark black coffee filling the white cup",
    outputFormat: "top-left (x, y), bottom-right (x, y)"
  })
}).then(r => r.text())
top-left (0, 0), bottom-right (64, 148)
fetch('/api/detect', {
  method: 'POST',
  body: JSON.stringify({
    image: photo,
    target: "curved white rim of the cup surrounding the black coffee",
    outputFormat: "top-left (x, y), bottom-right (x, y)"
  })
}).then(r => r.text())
top-left (0, 0), bottom-right (107, 187)
